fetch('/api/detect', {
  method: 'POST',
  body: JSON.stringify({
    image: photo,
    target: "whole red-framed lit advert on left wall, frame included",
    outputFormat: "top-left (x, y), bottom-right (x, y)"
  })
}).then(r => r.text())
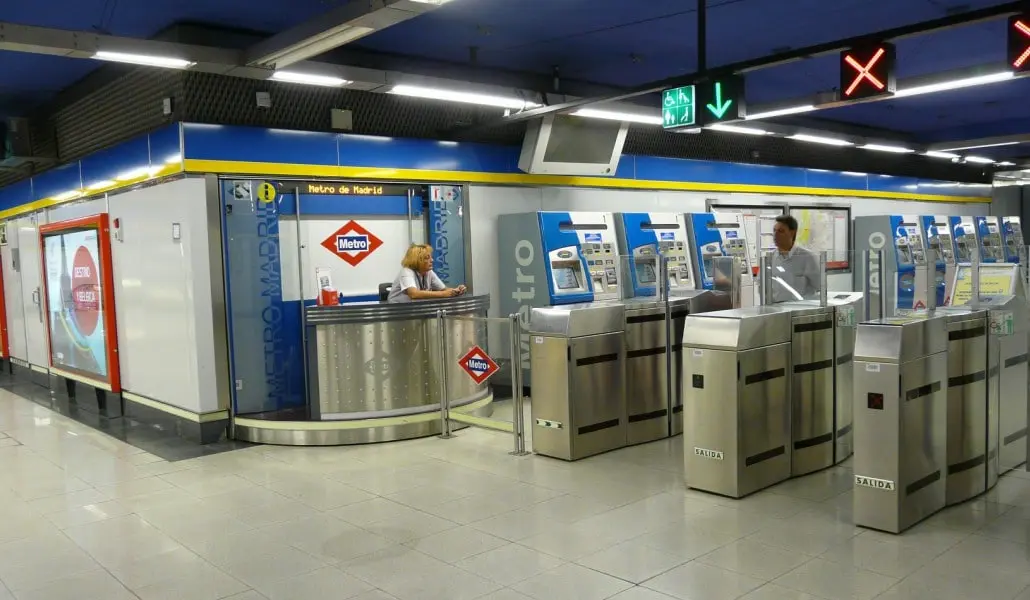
top-left (39, 214), bottom-right (121, 392)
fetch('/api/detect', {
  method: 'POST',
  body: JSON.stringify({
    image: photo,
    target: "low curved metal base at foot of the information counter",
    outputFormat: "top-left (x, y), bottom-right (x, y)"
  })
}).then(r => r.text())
top-left (233, 393), bottom-right (493, 446)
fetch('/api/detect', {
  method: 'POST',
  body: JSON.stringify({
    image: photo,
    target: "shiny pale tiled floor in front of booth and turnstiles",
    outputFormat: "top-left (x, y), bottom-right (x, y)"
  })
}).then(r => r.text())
top-left (0, 391), bottom-right (1030, 600)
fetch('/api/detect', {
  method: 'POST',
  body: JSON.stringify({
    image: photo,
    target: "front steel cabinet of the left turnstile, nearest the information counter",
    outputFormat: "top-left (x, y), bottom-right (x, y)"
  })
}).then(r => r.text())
top-left (528, 304), bottom-right (626, 460)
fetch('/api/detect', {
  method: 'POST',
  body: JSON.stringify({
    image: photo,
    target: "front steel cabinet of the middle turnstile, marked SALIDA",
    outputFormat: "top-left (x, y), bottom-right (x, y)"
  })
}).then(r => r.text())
top-left (683, 307), bottom-right (791, 498)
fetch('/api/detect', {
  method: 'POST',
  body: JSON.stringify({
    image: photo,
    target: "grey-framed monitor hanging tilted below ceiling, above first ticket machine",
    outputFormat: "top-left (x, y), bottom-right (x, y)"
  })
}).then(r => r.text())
top-left (518, 114), bottom-right (629, 177)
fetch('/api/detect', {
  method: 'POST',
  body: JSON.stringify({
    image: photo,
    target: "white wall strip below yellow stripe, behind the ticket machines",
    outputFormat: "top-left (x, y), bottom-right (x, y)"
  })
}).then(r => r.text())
top-left (469, 185), bottom-right (990, 316)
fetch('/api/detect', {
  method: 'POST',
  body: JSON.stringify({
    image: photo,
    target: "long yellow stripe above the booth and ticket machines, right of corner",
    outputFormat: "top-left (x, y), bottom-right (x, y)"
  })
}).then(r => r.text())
top-left (185, 160), bottom-right (991, 204)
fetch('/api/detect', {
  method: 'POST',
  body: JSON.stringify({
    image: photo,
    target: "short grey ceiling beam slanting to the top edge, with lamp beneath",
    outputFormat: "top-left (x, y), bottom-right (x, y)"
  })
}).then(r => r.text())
top-left (245, 0), bottom-right (440, 69)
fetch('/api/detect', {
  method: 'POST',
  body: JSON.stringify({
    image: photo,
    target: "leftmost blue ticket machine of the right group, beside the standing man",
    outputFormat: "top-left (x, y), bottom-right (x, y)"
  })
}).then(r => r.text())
top-left (855, 215), bottom-right (936, 319)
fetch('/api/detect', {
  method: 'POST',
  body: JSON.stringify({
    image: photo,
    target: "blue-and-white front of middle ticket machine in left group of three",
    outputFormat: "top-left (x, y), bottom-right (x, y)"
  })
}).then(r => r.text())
top-left (615, 212), bottom-right (696, 296)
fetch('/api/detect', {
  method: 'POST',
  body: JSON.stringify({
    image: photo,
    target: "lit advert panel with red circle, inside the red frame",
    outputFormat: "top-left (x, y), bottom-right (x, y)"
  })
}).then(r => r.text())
top-left (43, 228), bottom-right (108, 381)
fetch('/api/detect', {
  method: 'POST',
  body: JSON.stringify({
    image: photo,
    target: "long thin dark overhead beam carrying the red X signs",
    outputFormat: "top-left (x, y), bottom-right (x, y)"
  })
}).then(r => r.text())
top-left (482, 0), bottom-right (1028, 127)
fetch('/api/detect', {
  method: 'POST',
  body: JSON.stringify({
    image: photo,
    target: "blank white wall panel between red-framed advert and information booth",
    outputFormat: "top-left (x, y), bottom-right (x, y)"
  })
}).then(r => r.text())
top-left (110, 179), bottom-right (227, 413)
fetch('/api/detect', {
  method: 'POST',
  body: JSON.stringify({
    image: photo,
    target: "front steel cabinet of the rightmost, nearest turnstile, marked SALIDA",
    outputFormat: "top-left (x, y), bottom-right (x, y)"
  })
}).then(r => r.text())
top-left (854, 315), bottom-right (948, 533)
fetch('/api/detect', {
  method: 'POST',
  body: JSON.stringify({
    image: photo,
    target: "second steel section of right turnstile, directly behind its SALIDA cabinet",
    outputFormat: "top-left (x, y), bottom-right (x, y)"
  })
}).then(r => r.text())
top-left (938, 308), bottom-right (998, 505)
